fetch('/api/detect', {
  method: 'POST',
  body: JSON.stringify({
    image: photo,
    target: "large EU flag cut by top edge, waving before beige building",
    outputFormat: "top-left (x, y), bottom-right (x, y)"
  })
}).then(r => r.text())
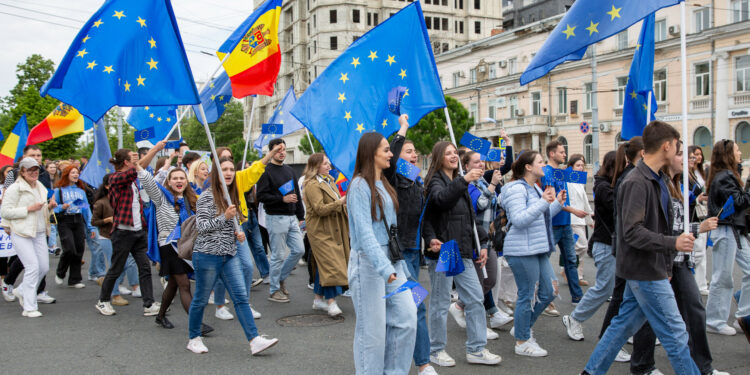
top-left (521, 0), bottom-right (681, 85)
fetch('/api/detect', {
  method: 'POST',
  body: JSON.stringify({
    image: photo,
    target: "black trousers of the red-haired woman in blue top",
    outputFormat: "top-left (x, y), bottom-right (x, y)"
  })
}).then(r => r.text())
top-left (56, 214), bottom-right (86, 285)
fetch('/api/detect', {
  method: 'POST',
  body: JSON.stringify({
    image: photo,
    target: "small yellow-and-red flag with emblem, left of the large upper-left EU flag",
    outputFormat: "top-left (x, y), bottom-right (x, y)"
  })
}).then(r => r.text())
top-left (27, 103), bottom-right (94, 145)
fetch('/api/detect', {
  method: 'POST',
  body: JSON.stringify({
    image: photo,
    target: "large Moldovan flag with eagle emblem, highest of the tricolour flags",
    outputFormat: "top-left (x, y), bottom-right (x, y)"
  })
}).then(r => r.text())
top-left (216, 0), bottom-right (282, 99)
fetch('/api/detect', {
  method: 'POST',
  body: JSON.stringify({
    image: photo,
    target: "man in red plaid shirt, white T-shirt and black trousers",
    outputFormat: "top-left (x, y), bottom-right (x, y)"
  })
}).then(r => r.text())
top-left (96, 149), bottom-right (160, 316)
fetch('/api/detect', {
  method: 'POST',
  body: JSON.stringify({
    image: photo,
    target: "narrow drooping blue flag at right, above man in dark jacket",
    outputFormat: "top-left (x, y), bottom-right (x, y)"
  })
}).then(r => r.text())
top-left (622, 13), bottom-right (658, 139)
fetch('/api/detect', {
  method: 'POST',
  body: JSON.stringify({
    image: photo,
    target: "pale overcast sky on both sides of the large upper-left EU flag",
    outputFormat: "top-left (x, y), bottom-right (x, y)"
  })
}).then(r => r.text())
top-left (0, 0), bottom-right (253, 97)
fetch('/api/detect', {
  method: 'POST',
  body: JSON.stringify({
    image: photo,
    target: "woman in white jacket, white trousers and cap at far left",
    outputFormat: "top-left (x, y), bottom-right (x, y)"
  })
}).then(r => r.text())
top-left (0, 157), bottom-right (54, 318)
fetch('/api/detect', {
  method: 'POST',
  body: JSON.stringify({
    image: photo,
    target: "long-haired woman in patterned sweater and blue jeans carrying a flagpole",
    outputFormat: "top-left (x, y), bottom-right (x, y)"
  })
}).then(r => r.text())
top-left (187, 159), bottom-right (279, 355)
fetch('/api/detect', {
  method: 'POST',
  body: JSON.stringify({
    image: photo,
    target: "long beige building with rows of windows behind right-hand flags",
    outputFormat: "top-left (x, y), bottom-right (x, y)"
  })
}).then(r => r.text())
top-left (436, 0), bottom-right (750, 167)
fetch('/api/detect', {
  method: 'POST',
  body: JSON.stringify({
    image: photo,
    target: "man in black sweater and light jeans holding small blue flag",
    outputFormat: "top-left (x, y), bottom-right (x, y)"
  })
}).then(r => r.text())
top-left (258, 138), bottom-right (305, 303)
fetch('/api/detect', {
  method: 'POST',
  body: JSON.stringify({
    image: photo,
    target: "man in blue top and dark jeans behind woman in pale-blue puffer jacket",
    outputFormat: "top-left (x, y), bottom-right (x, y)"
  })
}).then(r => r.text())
top-left (542, 141), bottom-right (588, 304)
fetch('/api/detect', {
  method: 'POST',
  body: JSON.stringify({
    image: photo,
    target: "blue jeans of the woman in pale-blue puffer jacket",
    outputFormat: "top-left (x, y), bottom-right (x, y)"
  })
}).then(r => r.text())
top-left (505, 253), bottom-right (560, 341)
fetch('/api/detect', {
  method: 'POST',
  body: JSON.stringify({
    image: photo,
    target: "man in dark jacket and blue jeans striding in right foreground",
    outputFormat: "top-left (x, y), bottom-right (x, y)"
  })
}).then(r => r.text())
top-left (583, 121), bottom-right (700, 375)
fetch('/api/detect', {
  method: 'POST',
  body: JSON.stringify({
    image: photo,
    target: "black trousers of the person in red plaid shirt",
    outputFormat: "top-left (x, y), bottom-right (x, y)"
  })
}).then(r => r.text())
top-left (99, 229), bottom-right (154, 307)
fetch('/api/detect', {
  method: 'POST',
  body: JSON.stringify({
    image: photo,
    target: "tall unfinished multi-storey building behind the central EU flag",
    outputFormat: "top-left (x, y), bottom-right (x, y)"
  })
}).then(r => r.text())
top-left (245, 0), bottom-right (502, 163)
